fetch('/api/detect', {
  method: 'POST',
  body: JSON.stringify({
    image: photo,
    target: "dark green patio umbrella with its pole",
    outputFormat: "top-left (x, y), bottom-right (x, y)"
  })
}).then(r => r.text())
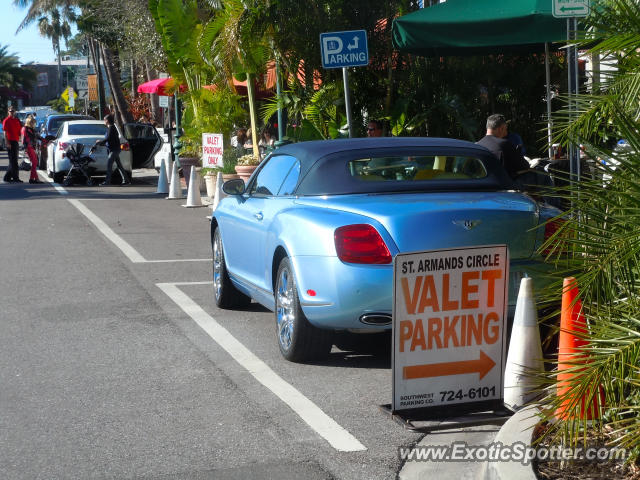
top-left (392, 0), bottom-right (567, 155)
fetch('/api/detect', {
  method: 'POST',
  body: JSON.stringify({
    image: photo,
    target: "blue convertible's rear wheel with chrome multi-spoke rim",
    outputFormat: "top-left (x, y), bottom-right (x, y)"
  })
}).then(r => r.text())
top-left (274, 257), bottom-right (332, 362)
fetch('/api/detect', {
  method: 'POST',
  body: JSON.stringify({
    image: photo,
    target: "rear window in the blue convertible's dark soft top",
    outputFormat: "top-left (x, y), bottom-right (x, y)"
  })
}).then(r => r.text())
top-left (348, 155), bottom-right (487, 182)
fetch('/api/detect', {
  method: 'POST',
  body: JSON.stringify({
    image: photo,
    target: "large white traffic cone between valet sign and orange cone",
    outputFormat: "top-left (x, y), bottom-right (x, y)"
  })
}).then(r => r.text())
top-left (504, 278), bottom-right (544, 411)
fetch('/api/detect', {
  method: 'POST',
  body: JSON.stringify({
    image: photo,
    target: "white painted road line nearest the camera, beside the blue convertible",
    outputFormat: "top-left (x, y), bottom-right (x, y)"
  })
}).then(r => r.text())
top-left (156, 282), bottom-right (367, 452)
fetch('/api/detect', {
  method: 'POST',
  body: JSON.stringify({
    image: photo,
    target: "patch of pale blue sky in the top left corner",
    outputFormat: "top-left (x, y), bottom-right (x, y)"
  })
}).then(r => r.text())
top-left (0, 0), bottom-right (64, 63)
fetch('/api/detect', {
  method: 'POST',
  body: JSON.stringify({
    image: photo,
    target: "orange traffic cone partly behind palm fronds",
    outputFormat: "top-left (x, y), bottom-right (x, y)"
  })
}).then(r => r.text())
top-left (555, 277), bottom-right (604, 420)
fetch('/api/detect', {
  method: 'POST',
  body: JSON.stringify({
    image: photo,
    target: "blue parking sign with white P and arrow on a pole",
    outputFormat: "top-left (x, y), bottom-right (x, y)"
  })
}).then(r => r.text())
top-left (320, 30), bottom-right (369, 68)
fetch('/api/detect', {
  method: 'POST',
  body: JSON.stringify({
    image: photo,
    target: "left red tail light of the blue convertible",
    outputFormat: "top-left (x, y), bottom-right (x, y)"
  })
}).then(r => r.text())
top-left (334, 224), bottom-right (391, 264)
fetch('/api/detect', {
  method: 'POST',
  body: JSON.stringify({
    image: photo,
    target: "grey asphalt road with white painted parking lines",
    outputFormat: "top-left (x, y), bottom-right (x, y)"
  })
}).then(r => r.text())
top-left (0, 152), bottom-right (430, 480)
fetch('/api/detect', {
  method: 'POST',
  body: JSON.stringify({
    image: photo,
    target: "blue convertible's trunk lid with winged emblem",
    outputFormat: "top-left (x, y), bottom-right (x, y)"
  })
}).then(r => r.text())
top-left (296, 192), bottom-right (539, 260)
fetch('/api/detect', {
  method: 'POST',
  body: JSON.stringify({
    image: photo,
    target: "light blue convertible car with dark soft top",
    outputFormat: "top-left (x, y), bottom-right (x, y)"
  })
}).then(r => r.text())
top-left (211, 138), bottom-right (559, 361)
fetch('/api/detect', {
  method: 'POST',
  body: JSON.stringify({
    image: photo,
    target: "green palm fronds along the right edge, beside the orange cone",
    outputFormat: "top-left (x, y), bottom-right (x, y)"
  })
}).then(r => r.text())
top-left (544, 0), bottom-right (640, 459)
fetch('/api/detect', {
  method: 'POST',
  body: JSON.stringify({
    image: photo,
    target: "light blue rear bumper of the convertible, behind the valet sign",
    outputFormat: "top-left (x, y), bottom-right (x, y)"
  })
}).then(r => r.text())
top-left (291, 256), bottom-right (551, 330)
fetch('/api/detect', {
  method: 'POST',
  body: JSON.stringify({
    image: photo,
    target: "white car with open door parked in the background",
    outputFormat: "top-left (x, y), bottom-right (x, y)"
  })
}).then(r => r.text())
top-left (47, 120), bottom-right (133, 183)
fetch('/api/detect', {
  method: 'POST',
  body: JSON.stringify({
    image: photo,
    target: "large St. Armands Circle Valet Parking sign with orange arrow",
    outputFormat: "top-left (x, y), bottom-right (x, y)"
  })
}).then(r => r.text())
top-left (392, 245), bottom-right (509, 412)
